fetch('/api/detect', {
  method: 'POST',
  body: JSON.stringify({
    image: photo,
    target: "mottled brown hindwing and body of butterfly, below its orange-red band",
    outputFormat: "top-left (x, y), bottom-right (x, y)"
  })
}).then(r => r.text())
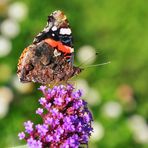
top-left (18, 41), bottom-right (80, 84)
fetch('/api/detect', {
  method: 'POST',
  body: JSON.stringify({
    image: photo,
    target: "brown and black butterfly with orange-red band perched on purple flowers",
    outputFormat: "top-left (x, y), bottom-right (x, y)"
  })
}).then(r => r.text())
top-left (17, 10), bottom-right (82, 84)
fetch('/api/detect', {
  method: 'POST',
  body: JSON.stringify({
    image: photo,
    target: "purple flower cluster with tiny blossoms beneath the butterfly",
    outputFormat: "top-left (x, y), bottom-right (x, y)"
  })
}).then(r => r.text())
top-left (18, 85), bottom-right (93, 148)
